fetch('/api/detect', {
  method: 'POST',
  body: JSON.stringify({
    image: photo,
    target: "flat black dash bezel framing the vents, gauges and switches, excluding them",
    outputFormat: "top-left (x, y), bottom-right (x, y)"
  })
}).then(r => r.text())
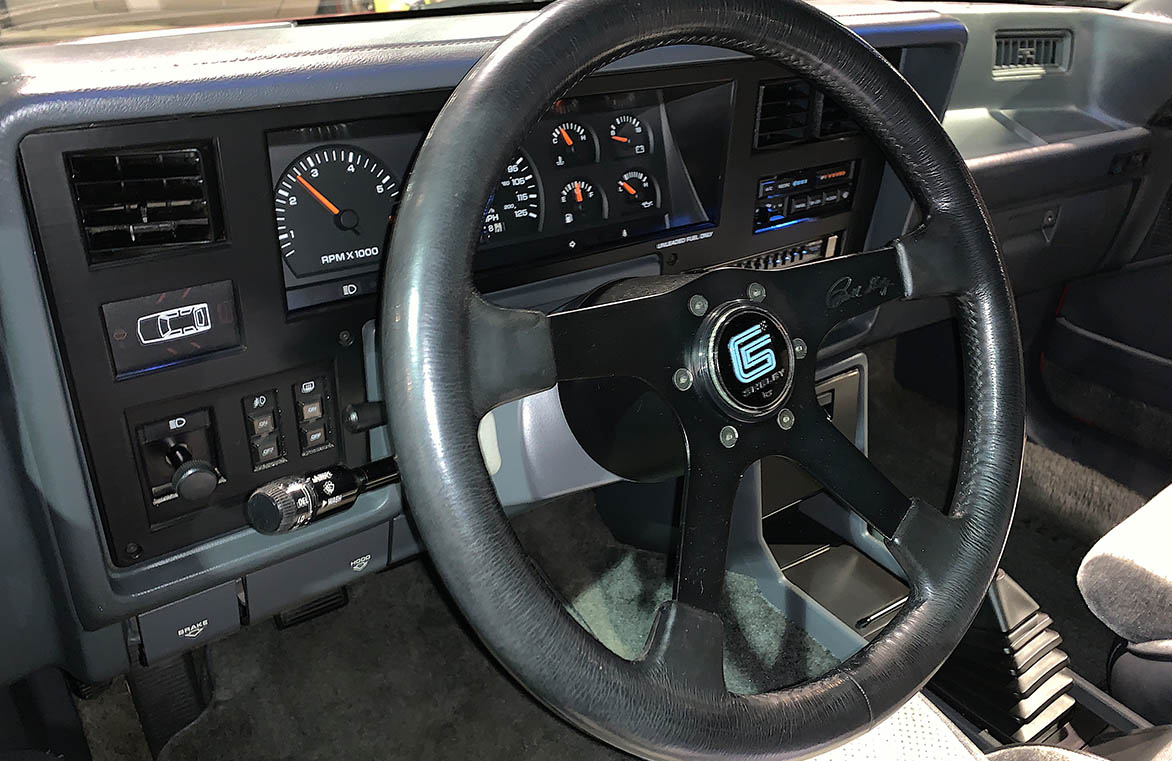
top-left (20, 61), bottom-right (883, 566)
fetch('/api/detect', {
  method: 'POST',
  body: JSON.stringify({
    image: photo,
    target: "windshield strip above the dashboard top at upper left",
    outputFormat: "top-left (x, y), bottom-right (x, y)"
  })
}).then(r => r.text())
top-left (0, 0), bottom-right (539, 45)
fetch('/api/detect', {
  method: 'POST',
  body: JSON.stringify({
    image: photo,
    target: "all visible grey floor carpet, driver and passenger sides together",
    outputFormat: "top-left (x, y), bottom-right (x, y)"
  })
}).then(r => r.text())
top-left (73, 344), bottom-right (1143, 761)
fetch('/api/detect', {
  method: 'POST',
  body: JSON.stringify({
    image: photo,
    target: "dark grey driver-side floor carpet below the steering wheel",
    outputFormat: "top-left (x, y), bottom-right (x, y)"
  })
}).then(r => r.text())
top-left (144, 498), bottom-right (836, 761)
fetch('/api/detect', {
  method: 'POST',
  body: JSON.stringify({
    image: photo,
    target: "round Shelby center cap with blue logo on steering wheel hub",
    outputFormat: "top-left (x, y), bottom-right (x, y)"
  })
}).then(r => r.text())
top-left (699, 301), bottom-right (793, 421)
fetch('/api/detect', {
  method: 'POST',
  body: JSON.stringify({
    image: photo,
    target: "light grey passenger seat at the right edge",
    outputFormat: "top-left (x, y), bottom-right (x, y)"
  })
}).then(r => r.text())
top-left (1078, 487), bottom-right (1172, 725)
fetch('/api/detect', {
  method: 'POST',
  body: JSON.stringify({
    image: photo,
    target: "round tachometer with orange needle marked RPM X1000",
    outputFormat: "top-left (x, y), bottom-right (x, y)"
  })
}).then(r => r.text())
top-left (275, 145), bottom-right (398, 277)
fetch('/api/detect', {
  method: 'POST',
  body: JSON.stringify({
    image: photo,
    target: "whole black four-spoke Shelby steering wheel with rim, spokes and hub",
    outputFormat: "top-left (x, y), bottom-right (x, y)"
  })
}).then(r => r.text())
top-left (381, 0), bottom-right (1023, 759)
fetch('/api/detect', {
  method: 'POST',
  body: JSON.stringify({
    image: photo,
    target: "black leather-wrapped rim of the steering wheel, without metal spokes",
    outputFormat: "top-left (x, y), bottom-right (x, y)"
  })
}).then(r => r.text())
top-left (380, 0), bottom-right (1023, 759)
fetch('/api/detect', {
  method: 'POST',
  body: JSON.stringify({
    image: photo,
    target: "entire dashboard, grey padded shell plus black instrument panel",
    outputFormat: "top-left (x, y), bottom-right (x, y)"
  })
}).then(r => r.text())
top-left (0, 0), bottom-right (1172, 681)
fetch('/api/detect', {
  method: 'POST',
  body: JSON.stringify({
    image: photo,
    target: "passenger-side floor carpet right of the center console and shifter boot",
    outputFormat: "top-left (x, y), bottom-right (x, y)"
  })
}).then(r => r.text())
top-left (867, 341), bottom-right (1144, 684)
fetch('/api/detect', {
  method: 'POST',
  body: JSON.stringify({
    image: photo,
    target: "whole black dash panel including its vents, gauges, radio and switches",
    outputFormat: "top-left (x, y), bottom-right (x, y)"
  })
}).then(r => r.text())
top-left (21, 60), bottom-right (881, 566)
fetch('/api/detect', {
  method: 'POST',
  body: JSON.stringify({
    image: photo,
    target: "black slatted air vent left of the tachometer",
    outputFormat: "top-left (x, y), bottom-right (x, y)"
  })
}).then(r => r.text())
top-left (68, 145), bottom-right (220, 264)
